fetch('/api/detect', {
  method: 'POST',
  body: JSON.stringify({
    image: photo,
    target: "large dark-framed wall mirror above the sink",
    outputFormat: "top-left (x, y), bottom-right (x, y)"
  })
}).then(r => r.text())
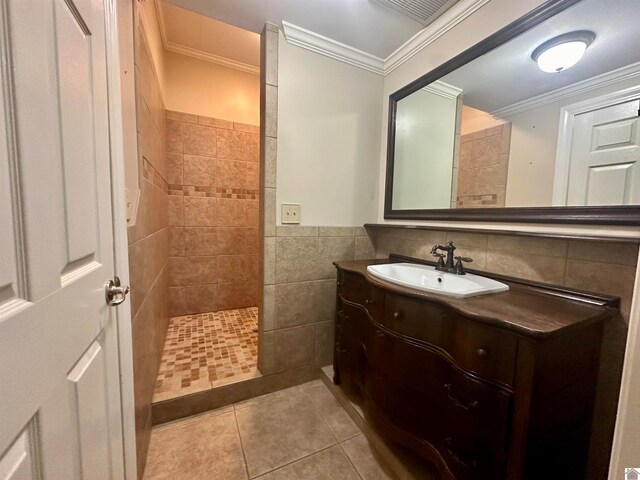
top-left (385, 0), bottom-right (640, 225)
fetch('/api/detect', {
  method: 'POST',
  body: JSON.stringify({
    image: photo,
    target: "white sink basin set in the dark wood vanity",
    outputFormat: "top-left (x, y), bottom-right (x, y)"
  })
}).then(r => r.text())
top-left (367, 263), bottom-right (509, 298)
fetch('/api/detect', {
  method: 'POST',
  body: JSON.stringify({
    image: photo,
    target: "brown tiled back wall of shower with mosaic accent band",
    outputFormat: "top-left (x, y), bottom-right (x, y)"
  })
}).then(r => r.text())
top-left (167, 111), bottom-right (260, 315)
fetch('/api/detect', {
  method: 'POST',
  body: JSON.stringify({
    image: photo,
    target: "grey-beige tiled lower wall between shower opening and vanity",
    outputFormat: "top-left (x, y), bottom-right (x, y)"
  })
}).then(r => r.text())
top-left (260, 226), bottom-right (375, 374)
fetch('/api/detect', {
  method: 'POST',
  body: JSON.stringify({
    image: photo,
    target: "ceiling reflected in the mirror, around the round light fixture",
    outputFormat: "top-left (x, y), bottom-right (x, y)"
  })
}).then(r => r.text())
top-left (442, 0), bottom-right (640, 112)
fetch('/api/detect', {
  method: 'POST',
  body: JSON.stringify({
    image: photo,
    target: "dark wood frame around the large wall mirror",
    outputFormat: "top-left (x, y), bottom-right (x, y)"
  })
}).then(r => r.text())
top-left (384, 0), bottom-right (640, 225)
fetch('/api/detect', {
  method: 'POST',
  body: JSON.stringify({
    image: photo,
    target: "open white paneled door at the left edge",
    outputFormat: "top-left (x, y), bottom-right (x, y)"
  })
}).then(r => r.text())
top-left (0, 0), bottom-right (124, 480)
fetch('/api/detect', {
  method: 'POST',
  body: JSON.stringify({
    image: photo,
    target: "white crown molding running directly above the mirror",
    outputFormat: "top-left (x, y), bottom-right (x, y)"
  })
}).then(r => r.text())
top-left (384, 0), bottom-right (491, 75)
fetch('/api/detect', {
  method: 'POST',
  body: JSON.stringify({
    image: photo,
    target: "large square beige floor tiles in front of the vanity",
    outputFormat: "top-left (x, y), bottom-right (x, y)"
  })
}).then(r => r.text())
top-left (144, 380), bottom-right (404, 480)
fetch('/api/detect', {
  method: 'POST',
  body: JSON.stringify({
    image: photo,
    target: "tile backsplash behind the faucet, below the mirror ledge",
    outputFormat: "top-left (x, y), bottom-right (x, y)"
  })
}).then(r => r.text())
top-left (372, 228), bottom-right (638, 321)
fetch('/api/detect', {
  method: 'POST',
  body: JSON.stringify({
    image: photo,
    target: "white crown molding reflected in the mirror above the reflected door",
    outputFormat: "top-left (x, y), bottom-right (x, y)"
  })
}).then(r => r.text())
top-left (490, 62), bottom-right (640, 118)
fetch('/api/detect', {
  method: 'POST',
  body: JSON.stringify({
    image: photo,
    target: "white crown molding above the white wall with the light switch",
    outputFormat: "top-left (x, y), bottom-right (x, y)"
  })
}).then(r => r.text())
top-left (282, 20), bottom-right (384, 75)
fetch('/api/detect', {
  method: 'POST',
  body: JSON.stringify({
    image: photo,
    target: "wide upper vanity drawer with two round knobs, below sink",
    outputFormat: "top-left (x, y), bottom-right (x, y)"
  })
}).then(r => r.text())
top-left (382, 293), bottom-right (518, 385)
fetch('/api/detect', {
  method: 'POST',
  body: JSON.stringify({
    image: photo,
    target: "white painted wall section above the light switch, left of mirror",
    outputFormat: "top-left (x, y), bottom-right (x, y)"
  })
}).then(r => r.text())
top-left (276, 35), bottom-right (383, 226)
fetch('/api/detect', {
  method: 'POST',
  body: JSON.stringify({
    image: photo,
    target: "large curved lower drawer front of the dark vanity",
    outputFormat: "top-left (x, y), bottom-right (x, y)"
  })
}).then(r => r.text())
top-left (366, 329), bottom-right (512, 479)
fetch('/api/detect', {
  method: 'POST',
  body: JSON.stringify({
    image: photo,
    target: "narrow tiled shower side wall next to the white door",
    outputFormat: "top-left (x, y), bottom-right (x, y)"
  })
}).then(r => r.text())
top-left (127, 18), bottom-right (169, 476)
